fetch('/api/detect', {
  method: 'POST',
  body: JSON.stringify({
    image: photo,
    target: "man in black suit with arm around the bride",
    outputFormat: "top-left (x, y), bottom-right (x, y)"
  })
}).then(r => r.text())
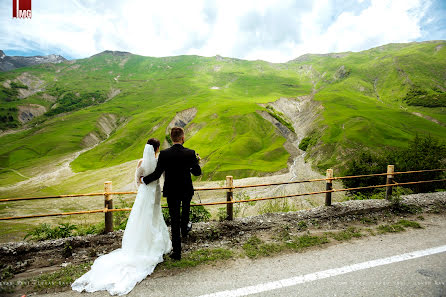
top-left (141, 127), bottom-right (201, 260)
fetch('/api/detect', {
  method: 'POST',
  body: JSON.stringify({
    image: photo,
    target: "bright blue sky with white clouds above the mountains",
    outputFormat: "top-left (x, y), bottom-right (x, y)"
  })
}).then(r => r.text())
top-left (0, 0), bottom-right (446, 62)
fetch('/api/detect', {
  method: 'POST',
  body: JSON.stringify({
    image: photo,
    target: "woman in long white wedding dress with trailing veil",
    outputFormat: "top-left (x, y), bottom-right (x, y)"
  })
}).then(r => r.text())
top-left (71, 138), bottom-right (172, 295)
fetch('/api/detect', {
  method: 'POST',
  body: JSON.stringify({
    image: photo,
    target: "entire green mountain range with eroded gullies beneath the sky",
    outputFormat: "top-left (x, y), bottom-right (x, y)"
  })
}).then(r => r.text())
top-left (0, 41), bottom-right (446, 196)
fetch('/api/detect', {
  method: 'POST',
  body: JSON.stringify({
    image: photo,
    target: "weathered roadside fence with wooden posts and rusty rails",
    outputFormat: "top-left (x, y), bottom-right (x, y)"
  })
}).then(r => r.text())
top-left (0, 165), bottom-right (446, 232)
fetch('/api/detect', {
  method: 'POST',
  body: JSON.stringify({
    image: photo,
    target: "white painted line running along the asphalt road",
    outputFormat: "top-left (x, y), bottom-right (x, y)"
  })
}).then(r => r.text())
top-left (199, 245), bottom-right (446, 297)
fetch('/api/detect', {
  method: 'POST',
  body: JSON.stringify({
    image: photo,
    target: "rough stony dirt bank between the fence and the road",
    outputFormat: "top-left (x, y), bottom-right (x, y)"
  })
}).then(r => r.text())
top-left (0, 192), bottom-right (446, 290)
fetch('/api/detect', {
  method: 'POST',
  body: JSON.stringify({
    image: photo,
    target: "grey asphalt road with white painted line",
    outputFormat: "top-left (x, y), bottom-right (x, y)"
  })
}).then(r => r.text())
top-left (40, 216), bottom-right (446, 297)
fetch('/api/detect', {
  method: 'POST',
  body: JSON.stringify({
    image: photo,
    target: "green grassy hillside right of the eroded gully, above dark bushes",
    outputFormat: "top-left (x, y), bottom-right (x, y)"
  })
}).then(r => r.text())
top-left (290, 41), bottom-right (446, 169)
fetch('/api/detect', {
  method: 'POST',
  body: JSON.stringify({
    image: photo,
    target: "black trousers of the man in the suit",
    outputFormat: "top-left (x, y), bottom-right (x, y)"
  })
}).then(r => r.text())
top-left (167, 195), bottom-right (192, 255)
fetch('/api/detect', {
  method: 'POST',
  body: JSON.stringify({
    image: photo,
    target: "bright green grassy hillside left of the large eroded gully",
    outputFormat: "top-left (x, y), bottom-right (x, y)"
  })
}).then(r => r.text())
top-left (0, 53), bottom-right (311, 190)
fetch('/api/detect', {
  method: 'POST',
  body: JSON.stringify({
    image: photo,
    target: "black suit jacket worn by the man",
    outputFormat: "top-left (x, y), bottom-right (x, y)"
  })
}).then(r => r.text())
top-left (143, 144), bottom-right (201, 197)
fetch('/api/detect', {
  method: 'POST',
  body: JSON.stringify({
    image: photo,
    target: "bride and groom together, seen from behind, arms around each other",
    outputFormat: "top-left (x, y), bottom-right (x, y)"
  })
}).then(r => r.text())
top-left (71, 127), bottom-right (201, 295)
